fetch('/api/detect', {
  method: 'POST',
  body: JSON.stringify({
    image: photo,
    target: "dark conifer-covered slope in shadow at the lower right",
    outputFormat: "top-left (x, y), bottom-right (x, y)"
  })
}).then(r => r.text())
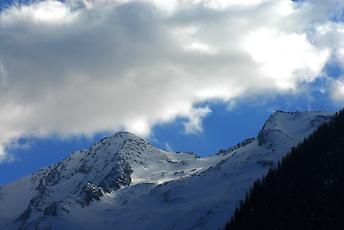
top-left (225, 110), bottom-right (344, 230)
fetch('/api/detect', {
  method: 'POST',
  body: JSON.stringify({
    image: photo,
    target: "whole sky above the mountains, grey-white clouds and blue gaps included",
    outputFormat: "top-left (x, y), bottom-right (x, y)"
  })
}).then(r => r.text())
top-left (0, 0), bottom-right (344, 183)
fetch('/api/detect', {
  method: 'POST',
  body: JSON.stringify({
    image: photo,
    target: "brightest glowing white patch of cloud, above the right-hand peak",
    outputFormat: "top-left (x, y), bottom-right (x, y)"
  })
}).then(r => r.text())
top-left (246, 28), bottom-right (329, 90)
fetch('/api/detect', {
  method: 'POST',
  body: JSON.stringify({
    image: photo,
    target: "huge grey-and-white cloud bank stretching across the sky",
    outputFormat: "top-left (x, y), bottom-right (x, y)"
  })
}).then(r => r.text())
top-left (0, 0), bottom-right (344, 160)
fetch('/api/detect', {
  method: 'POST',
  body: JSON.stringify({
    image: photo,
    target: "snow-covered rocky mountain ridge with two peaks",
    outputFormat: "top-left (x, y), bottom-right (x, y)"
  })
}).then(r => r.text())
top-left (0, 111), bottom-right (331, 230)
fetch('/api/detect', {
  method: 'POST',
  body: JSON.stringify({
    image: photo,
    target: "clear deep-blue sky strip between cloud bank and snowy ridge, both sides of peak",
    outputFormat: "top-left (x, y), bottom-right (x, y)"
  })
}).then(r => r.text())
top-left (0, 90), bottom-right (341, 184)
